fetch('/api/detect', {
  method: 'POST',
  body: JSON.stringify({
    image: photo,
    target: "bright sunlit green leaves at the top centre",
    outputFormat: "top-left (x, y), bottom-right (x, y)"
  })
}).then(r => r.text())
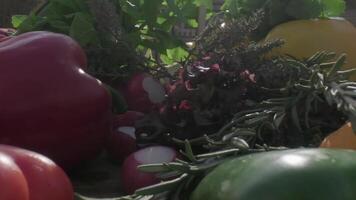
top-left (115, 0), bottom-right (206, 64)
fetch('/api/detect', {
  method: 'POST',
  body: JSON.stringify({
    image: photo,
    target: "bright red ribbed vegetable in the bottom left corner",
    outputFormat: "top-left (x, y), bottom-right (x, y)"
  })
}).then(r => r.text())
top-left (0, 145), bottom-right (74, 200)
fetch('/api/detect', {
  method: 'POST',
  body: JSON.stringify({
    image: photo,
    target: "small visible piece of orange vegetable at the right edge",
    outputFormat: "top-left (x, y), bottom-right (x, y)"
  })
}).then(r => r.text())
top-left (320, 122), bottom-right (356, 150)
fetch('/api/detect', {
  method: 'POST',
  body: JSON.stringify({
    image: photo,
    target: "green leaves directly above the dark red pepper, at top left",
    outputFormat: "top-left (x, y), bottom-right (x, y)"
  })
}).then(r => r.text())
top-left (12, 0), bottom-right (92, 41)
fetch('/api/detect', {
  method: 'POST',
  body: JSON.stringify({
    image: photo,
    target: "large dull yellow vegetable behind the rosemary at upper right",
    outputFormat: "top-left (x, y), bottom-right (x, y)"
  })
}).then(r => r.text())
top-left (265, 18), bottom-right (356, 80)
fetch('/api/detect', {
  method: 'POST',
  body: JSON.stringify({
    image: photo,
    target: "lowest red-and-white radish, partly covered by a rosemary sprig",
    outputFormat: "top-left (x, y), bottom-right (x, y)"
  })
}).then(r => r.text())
top-left (121, 146), bottom-right (178, 194)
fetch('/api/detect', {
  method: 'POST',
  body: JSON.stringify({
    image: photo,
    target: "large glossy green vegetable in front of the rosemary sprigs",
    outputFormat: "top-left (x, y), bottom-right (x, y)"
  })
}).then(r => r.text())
top-left (191, 148), bottom-right (356, 200)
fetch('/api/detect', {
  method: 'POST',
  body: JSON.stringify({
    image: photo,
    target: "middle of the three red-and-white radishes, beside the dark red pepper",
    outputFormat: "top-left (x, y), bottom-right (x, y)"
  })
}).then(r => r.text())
top-left (106, 111), bottom-right (144, 162)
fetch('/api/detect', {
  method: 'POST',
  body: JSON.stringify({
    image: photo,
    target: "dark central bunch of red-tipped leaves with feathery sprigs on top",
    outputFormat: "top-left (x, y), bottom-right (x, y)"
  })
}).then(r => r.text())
top-left (138, 13), bottom-right (281, 142)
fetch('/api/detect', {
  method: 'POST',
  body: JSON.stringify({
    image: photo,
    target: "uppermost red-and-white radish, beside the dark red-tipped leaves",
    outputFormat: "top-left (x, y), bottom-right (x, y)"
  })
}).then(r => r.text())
top-left (122, 73), bottom-right (165, 113)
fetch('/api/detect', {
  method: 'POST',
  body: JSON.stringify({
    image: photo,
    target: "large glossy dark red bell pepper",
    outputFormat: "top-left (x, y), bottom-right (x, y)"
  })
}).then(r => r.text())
top-left (0, 31), bottom-right (112, 169)
